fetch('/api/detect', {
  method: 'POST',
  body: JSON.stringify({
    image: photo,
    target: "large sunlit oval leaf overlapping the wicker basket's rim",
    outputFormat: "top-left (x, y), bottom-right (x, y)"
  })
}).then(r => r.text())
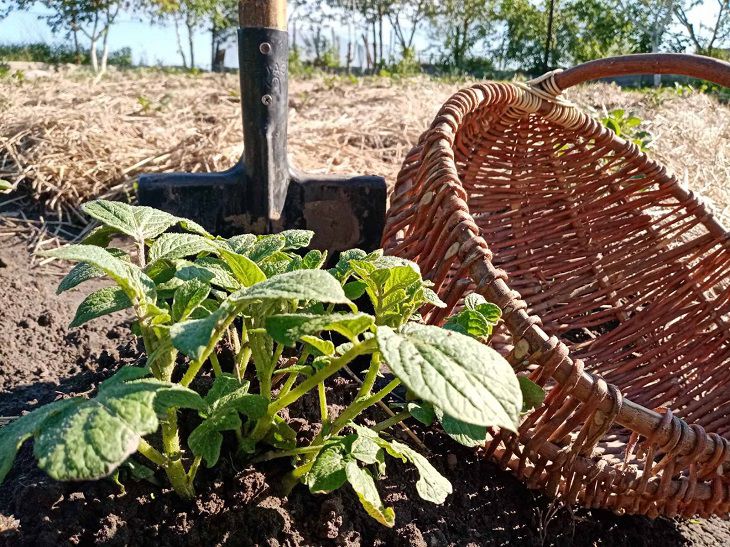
top-left (376, 323), bottom-right (522, 431)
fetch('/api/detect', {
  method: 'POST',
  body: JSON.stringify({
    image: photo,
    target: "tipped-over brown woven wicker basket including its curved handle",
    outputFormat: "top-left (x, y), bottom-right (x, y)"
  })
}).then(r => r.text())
top-left (383, 54), bottom-right (730, 517)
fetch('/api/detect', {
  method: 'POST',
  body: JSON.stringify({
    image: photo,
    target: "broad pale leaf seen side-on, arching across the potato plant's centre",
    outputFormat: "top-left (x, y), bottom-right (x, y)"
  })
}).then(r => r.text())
top-left (231, 270), bottom-right (351, 304)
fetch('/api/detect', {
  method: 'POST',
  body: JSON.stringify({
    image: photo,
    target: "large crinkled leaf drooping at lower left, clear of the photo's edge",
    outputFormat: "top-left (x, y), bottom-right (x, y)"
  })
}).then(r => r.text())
top-left (34, 371), bottom-right (196, 480)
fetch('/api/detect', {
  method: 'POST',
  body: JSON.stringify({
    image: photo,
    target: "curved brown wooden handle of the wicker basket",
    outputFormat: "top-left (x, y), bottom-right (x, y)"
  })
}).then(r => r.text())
top-left (552, 53), bottom-right (730, 91)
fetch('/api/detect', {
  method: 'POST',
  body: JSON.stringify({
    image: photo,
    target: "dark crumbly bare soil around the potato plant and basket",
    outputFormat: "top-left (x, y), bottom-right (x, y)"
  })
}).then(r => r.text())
top-left (0, 233), bottom-right (730, 547)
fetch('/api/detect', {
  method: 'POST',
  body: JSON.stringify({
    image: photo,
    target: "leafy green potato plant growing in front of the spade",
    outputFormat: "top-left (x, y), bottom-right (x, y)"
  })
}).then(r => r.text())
top-left (0, 200), bottom-right (523, 526)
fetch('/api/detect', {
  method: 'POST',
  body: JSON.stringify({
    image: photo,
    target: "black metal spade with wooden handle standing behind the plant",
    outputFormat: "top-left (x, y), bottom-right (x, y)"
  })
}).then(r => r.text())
top-left (138, 0), bottom-right (386, 251)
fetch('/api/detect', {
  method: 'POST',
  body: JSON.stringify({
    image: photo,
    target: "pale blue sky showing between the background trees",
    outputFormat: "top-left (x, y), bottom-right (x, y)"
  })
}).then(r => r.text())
top-left (0, 0), bottom-right (716, 68)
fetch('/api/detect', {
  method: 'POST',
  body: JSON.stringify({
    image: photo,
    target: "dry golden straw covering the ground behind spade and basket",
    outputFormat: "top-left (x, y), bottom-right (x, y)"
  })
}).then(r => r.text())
top-left (0, 71), bottom-right (730, 224)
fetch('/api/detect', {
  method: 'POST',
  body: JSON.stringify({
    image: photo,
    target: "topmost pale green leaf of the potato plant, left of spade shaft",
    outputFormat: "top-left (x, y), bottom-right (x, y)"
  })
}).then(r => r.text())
top-left (82, 199), bottom-right (180, 241)
